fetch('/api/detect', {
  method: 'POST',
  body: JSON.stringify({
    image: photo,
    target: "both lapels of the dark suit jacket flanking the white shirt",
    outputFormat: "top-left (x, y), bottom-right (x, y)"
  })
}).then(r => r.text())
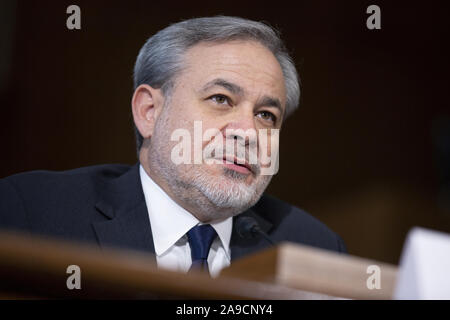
top-left (92, 163), bottom-right (272, 261)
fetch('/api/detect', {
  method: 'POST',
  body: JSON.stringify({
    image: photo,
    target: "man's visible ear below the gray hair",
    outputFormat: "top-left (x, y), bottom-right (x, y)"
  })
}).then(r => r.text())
top-left (131, 84), bottom-right (164, 139)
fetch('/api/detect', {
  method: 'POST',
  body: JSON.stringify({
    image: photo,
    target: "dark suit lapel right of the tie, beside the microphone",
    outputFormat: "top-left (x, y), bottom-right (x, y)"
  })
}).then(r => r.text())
top-left (230, 209), bottom-right (273, 261)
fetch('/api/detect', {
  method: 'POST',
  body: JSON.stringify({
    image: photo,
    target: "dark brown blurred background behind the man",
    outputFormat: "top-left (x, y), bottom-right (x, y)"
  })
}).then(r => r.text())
top-left (0, 0), bottom-right (450, 263)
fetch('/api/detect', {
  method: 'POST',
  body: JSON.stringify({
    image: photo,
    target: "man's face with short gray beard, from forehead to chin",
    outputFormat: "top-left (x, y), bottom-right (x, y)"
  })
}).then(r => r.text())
top-left (148, 41), bottom-right (286, 221)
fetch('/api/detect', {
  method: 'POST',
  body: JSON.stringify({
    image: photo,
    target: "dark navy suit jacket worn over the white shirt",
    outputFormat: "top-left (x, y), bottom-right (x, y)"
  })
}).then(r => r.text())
top-left (0, 164), bottom-right (346, 260)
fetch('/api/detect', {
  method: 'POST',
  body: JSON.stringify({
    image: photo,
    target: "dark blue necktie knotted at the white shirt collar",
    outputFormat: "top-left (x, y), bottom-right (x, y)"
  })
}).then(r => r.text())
top-left (187, 224), bottom-right (217, 273)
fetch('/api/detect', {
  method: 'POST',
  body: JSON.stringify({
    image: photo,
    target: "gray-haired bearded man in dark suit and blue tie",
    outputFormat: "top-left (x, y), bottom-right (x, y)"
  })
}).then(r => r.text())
top-left (0, 17), bottom-right (345, 276)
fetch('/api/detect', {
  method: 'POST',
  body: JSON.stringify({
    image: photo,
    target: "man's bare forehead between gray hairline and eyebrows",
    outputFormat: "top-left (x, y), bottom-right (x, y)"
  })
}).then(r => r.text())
top-left (179, 41), bottom-right (286, 104)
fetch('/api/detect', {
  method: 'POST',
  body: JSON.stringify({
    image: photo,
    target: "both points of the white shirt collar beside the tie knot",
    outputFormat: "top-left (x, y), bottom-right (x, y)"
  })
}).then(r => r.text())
top-left (139, 165), bottom-right (233, 259)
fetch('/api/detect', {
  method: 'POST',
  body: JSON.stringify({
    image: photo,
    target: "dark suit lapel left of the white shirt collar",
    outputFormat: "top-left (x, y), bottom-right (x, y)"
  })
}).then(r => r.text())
top-left (93, 163), bottom-right (155, 254)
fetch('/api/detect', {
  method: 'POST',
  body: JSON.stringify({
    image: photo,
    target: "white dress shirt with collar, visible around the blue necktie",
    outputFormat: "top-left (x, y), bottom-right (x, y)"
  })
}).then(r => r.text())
top-left (139, 165), bottom-right (233, 277)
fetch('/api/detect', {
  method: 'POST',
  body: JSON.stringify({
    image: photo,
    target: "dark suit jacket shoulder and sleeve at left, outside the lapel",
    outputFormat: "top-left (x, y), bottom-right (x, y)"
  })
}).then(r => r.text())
top-left (0, 164), bottom-right (130, 234)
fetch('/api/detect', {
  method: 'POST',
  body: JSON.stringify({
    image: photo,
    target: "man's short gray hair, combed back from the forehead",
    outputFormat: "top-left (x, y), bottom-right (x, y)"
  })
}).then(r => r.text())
top-left (134, 16), bottom-right (300, 156)
